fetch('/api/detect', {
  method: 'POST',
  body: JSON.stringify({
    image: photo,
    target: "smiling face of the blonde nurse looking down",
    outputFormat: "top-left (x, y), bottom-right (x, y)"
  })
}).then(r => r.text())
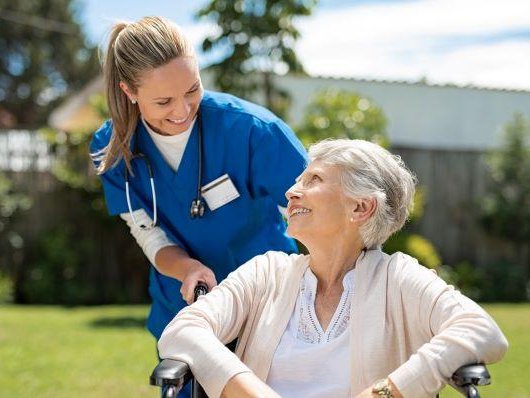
top-left (120, 57), bottom-right (203, 135)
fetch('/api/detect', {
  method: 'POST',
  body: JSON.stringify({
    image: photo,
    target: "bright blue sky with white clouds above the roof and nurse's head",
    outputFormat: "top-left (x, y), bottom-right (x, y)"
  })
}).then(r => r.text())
top-left (79, 0), bottom-right (530, 90)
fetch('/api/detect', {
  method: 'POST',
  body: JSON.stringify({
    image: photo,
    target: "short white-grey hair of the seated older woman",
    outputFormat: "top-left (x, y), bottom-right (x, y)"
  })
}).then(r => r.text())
top-left (309, 139), bottom-right (416, 249)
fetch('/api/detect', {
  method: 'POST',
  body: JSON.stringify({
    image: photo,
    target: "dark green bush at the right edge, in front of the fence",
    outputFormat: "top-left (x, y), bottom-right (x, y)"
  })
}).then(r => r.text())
top-left (481, 113), bottom-right (530, 277)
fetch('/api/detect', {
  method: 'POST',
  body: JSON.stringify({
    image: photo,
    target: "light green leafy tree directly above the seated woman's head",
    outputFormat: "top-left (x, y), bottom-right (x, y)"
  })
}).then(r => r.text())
top-left (296, 89), bottom-right (389, 147)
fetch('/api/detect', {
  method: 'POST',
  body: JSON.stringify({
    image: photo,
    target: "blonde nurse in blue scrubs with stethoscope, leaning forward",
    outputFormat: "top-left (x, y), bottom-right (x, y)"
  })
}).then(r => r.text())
top-left (90, 17), bottom-right (306, 339)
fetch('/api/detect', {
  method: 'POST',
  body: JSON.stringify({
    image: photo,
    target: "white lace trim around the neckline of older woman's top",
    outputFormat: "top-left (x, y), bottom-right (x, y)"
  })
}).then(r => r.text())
top-left (296, 269), bottom-right (353, 344)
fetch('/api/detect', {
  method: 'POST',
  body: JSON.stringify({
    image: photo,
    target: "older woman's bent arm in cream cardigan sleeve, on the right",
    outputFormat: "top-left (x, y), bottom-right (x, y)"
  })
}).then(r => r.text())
top-left (389, 261), bottom-right (508, 397)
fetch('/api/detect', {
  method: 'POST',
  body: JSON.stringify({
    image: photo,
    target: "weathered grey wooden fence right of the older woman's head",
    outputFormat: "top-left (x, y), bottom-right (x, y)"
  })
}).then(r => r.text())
top-left (392, 147), bottom-right (515, 266)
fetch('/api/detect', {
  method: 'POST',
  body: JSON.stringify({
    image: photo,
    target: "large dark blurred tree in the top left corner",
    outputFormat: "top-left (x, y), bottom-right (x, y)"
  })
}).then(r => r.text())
top-left (0, 0), bottom-right (99, 127)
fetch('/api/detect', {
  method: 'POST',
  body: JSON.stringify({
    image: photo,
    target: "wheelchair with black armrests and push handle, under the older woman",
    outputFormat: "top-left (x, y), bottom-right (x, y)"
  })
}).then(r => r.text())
top-left (149, 283), bottom-right (491, 398)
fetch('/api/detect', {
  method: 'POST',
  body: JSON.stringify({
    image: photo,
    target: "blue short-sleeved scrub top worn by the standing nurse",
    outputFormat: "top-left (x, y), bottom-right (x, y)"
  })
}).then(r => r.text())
top-left (91, 91), bottom-right (307, 339)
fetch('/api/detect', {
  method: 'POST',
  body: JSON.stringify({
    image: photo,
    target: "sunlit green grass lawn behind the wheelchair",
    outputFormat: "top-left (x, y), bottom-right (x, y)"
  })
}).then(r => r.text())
top-left (0, 304), bottom-right (530, 398)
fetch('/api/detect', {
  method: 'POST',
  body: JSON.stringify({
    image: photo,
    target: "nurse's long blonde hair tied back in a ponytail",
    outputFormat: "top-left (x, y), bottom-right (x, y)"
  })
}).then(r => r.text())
top-left (92, 17), bottom-right (195, 174)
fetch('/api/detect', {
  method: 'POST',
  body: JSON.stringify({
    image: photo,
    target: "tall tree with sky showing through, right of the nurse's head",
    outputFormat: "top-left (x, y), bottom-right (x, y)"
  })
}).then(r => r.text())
top-left (197, 0), bottom-right (317, 116)
